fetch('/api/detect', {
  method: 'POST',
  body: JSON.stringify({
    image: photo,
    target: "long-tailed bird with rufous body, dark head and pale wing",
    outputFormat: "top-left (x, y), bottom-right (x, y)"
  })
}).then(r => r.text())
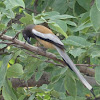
top-left (22, 24), bottom-right (95, 97)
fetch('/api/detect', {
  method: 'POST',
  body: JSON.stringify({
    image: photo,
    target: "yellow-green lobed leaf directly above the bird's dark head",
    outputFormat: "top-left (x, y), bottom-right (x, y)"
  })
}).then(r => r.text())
top-left (20, 13), bottom-right (33, 25)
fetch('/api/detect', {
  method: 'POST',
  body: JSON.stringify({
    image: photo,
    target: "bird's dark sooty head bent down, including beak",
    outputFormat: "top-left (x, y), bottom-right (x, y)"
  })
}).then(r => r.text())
top-left (22, 24), bottom-right (35, 44)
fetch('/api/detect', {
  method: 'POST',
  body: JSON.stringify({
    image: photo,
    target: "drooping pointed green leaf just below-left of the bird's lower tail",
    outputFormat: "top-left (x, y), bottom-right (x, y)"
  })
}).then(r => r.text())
top-left (64, 71), bottom-right (77, 97)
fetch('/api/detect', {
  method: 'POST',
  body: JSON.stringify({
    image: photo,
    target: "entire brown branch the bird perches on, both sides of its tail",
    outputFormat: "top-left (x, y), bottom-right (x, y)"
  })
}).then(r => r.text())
top-left (0, 35), bottom-right (95, 76)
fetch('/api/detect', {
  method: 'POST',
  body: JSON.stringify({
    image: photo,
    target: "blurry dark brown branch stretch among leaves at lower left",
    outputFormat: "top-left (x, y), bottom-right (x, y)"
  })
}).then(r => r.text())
top-left (10, 73), bottom-right (49, 88)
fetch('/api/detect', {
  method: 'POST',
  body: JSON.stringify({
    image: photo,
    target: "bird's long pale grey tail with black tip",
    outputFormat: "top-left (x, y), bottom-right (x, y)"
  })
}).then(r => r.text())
top-left (55, 47), bottom-right (95, 97)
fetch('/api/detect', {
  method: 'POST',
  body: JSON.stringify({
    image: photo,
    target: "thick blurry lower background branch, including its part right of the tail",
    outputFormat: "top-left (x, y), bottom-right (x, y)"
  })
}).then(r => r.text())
top-left (10, 73), bottom-right (98, 88)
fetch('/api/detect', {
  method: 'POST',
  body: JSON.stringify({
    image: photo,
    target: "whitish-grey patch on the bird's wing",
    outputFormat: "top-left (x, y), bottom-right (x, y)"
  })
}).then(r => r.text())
top-left (32, 29), bottom-right (64, 45)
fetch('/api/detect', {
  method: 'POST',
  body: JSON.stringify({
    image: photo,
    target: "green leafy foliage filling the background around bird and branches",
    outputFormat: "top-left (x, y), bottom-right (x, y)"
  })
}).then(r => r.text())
top-left (0, 0), bottom-right (100, 100)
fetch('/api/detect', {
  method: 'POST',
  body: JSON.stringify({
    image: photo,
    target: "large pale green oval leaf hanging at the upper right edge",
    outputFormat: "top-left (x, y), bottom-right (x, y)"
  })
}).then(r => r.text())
top-left (90, 4), bottom-right (100, 31)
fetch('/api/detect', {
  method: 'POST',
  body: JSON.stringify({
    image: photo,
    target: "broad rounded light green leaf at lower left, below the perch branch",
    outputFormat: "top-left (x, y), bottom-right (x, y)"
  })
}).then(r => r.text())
top-left (7, 63), bottom-right (23, 78)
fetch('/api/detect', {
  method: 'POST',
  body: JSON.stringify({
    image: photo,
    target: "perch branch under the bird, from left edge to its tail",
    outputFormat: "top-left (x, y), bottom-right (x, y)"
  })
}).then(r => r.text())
top-left (0, 35), bottom-right (65, 65)
